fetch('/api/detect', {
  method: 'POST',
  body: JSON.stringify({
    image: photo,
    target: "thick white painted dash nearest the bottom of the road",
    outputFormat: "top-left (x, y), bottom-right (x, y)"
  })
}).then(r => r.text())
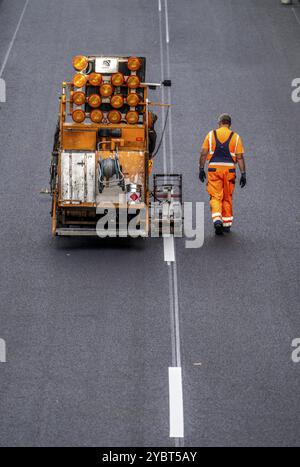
top-left (169, 367), bottom-right (184, 438)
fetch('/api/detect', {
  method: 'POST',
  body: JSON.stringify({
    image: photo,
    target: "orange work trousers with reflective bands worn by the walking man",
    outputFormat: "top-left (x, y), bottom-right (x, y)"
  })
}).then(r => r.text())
top-left (207, 166), bottom-right (236, 227)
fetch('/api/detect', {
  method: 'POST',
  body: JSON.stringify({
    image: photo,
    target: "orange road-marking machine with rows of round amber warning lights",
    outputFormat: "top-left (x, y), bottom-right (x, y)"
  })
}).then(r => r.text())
top-left (50, 56), bottom-right (182, 237)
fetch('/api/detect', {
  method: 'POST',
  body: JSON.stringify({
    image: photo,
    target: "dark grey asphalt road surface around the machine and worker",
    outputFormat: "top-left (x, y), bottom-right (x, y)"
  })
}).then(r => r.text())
top-left (0, 0), bottom-right (300, 447)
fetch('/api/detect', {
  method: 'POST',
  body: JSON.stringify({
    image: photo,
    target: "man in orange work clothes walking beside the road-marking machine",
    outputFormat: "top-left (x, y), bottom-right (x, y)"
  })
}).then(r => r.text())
top-left (199, 114), bottom-right (246, 235)
